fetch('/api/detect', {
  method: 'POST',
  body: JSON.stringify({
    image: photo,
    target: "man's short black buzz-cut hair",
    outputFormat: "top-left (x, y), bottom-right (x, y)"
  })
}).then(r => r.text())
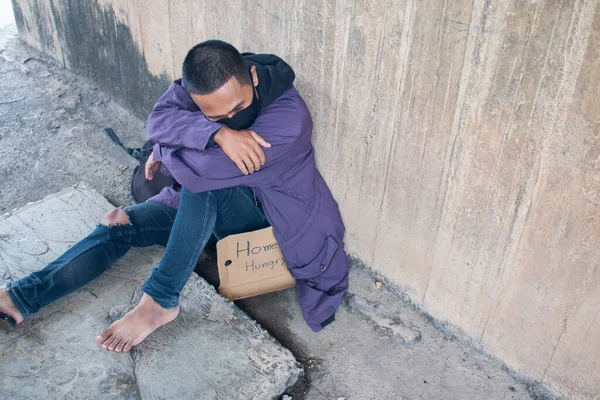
top-left (181, 40), bottom-right (251, 94)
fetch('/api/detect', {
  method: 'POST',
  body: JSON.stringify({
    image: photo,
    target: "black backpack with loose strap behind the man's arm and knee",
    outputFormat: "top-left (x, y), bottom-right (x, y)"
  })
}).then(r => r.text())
top-left (104, 128), bottom-right (179, 203)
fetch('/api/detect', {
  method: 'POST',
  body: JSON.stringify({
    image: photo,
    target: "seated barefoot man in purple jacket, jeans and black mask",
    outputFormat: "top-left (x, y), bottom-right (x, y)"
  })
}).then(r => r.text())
top-left (0, 40), bottom-right (348, 351)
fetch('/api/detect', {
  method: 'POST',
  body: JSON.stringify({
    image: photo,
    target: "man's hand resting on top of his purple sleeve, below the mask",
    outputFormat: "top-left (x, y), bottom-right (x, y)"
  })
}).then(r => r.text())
top-left (213, 126), bottom-right (271, 175)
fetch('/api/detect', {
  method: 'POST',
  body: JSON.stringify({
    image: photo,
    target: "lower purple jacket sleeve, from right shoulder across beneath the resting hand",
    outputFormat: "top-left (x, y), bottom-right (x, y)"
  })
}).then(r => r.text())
top-left (155, 95), bottom-right (304, 192)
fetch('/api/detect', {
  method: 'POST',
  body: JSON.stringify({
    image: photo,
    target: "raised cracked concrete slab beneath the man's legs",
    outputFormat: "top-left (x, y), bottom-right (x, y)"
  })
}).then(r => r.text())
top-left (0, 184), bottom-right (301, 399)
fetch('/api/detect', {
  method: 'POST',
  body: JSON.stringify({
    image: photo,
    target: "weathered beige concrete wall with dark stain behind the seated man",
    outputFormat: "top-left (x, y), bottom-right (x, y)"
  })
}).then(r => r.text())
top-left (14, 0), bottom-right (600, 398)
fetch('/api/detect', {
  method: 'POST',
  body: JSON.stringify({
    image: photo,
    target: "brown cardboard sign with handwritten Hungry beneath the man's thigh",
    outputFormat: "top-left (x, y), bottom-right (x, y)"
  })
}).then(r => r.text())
top-left (217, 227), bottom-right (296, 300)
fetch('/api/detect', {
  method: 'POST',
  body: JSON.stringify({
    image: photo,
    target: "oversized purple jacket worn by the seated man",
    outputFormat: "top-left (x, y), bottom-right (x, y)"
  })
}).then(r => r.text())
top-left (148, 80), bottom-right (349, 332)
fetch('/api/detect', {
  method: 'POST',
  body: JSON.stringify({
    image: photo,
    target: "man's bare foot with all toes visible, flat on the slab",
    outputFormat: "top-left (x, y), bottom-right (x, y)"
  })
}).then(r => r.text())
top-left (96, 293), bottom-right (179, 352)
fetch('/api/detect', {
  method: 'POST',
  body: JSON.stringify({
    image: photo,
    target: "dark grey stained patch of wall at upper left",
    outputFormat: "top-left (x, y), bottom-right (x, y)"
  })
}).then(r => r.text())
top-left (13, 0), bottom-right (171, 119)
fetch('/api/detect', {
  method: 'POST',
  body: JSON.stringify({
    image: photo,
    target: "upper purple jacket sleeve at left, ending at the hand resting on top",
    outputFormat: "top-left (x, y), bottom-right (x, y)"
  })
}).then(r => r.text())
top-left (147, 80), bottom-right (223, 150)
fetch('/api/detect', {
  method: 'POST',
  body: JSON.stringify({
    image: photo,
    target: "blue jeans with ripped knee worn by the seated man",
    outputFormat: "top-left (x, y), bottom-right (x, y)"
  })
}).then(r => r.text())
top-left (7, 186), bottom-right (269, 318)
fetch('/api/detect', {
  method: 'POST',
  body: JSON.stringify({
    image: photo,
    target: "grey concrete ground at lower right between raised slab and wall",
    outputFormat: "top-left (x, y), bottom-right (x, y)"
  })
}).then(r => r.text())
top-left (237, 262), bottom-right (553, 400)
